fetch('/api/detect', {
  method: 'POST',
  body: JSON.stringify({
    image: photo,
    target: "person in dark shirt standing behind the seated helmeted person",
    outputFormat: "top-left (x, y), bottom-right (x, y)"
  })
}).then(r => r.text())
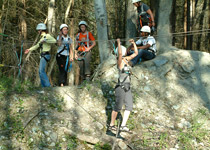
top-left (132, 0), bottom-right (155, 31)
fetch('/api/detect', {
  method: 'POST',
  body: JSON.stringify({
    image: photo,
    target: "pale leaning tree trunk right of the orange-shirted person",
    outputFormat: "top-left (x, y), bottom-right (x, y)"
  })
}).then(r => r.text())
top-left (95, 0), bottom-right (110, 62)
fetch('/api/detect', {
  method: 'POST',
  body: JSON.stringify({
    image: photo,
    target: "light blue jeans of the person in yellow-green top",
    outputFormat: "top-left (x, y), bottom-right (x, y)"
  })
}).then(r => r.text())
top-left (39, 55), bottom-right (50, 87)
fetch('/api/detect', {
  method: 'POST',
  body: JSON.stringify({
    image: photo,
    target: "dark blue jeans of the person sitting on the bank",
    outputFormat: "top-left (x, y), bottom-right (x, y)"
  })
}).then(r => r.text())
top-left (131, 49), bottom-right (155, 66)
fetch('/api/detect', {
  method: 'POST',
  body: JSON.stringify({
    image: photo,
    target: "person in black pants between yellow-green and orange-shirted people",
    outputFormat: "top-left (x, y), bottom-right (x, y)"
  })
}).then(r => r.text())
top-left (56, 24), bottom-right (73, 86)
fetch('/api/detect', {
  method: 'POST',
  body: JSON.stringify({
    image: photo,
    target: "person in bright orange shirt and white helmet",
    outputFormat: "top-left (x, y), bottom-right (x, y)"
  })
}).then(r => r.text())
top-left (75, 21), bottom-right (96, 80)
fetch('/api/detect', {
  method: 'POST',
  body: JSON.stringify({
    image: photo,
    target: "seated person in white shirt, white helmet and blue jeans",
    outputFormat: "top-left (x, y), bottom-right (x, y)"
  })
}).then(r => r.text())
top-left (127, 26), bottom-right (157, 66)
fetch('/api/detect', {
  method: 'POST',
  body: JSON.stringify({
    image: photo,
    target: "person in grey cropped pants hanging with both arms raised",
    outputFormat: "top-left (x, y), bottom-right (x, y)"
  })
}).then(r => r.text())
top-left (108, 39), bottom-right (138, 132)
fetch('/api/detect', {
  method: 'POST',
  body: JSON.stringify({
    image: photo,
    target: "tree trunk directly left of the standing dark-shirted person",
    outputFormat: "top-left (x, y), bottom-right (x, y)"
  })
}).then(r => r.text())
top-left (126, 0), bottom-right (137, 45)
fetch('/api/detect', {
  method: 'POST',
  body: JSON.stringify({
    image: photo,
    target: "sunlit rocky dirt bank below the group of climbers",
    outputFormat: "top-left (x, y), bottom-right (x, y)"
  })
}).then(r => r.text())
top-left (0, 50), bottom-right (210, 150)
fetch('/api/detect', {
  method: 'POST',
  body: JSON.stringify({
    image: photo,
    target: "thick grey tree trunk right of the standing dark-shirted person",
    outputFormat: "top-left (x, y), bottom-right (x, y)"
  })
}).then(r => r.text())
top-left (157, 0), bottom-right (173, 53)
